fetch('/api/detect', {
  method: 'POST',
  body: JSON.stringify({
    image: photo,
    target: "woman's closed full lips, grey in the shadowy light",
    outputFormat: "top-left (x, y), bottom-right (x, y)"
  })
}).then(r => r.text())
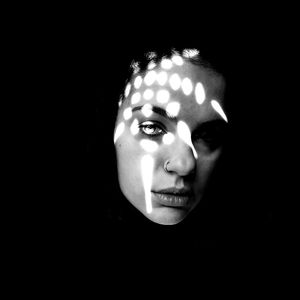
top-left (152, 188), bottom-right (192, 208)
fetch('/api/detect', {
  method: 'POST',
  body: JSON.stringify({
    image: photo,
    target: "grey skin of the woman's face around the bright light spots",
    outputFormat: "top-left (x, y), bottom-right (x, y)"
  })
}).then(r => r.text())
top-left (115, 61), bottom-right (225, 225)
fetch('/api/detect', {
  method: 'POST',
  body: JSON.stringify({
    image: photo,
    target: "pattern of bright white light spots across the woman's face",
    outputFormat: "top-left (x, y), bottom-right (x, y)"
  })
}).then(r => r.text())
top-left (114, 49), bottom-right (228, 223)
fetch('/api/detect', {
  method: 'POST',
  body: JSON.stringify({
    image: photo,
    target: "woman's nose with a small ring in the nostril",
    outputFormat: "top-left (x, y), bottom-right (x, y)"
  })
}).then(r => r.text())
top-left (168, 138), bottom-right (196, 176)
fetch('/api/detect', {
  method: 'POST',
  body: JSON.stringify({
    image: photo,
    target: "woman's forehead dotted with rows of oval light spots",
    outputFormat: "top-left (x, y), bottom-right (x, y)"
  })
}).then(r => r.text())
top-left (119, 60), bottom-right (225, 124)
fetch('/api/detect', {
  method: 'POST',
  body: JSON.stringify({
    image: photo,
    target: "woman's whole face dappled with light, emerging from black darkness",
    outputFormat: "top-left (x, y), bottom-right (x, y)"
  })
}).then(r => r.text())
top-left (114, 57), bottom-right (227, 225)
